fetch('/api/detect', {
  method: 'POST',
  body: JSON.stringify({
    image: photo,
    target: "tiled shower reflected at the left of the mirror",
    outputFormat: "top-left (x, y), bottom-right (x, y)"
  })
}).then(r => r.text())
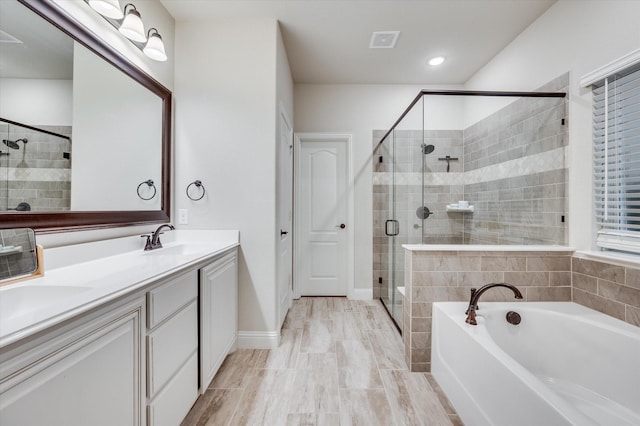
top-left (0, 118), bottom-right (71, 212)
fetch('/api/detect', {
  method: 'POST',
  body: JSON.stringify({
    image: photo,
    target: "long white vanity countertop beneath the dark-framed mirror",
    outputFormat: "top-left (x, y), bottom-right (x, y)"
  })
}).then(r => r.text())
top-left (0, 230), bottom-right (240, 348)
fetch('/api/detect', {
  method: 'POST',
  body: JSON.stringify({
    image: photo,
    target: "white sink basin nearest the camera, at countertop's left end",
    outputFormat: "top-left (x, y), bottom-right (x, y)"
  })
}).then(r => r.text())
top-left (0, 285), bottom-right (91, 320)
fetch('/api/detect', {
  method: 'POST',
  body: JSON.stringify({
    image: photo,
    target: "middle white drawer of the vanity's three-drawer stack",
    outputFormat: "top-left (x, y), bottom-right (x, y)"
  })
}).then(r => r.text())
top-left (147, 301), bottom-right (198, 398)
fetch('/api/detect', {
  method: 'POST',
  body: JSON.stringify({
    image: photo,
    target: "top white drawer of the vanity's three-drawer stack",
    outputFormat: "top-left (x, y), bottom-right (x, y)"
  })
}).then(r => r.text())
top-left (147, 271), bottom-right (198, 329)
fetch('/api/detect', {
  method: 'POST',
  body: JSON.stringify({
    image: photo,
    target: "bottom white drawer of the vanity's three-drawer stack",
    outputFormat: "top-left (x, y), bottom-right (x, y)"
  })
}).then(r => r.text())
top-left (147, 353), bottom-right (198, 426)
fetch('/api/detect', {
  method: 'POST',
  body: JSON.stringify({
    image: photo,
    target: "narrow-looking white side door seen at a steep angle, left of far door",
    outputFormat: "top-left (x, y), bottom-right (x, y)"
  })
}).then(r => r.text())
top-left (277, 109), bottom-right (293, 328)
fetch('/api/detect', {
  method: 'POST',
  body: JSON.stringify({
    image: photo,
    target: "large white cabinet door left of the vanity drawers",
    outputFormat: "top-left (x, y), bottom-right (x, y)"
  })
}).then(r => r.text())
top-left (0, 299), bottom-right (144, 426)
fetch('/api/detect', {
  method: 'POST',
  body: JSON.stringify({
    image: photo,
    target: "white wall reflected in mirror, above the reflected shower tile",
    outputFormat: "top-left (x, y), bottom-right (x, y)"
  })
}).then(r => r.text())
top-left (0, 78), bottom-right (73, 126)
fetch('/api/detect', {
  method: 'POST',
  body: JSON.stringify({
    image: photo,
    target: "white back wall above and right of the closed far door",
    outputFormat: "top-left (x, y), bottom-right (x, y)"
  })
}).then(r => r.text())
top-left (294, 84), bottom-right (462, 289)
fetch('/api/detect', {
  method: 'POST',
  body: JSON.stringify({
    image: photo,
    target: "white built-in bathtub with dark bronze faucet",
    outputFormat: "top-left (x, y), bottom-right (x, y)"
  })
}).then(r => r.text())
top-left (431, 301), bottom-right (640, 426)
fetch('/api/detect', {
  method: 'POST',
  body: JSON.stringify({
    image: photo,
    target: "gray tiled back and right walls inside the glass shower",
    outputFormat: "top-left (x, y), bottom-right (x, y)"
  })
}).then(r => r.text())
top-left (372, 74), bottom-right (569, 298)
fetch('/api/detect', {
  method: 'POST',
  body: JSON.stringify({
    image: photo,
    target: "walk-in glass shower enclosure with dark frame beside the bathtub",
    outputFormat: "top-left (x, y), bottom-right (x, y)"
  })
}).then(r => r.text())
top-left (373, 75), bottom-right (568, 329)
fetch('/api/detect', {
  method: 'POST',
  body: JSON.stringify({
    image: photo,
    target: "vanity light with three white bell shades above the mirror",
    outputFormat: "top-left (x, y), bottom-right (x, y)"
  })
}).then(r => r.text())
top-left (85, 0), bottom-right (167, 62)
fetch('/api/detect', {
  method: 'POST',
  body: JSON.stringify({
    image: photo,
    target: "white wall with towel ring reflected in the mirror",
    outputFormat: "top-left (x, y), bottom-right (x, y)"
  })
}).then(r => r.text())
top-left (71, 42), bottom-right (162, 211)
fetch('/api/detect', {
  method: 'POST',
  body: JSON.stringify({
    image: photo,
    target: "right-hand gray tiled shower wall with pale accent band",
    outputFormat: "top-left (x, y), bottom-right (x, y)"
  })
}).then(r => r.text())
top-left (464, 74), bottom-right (569, 244)
